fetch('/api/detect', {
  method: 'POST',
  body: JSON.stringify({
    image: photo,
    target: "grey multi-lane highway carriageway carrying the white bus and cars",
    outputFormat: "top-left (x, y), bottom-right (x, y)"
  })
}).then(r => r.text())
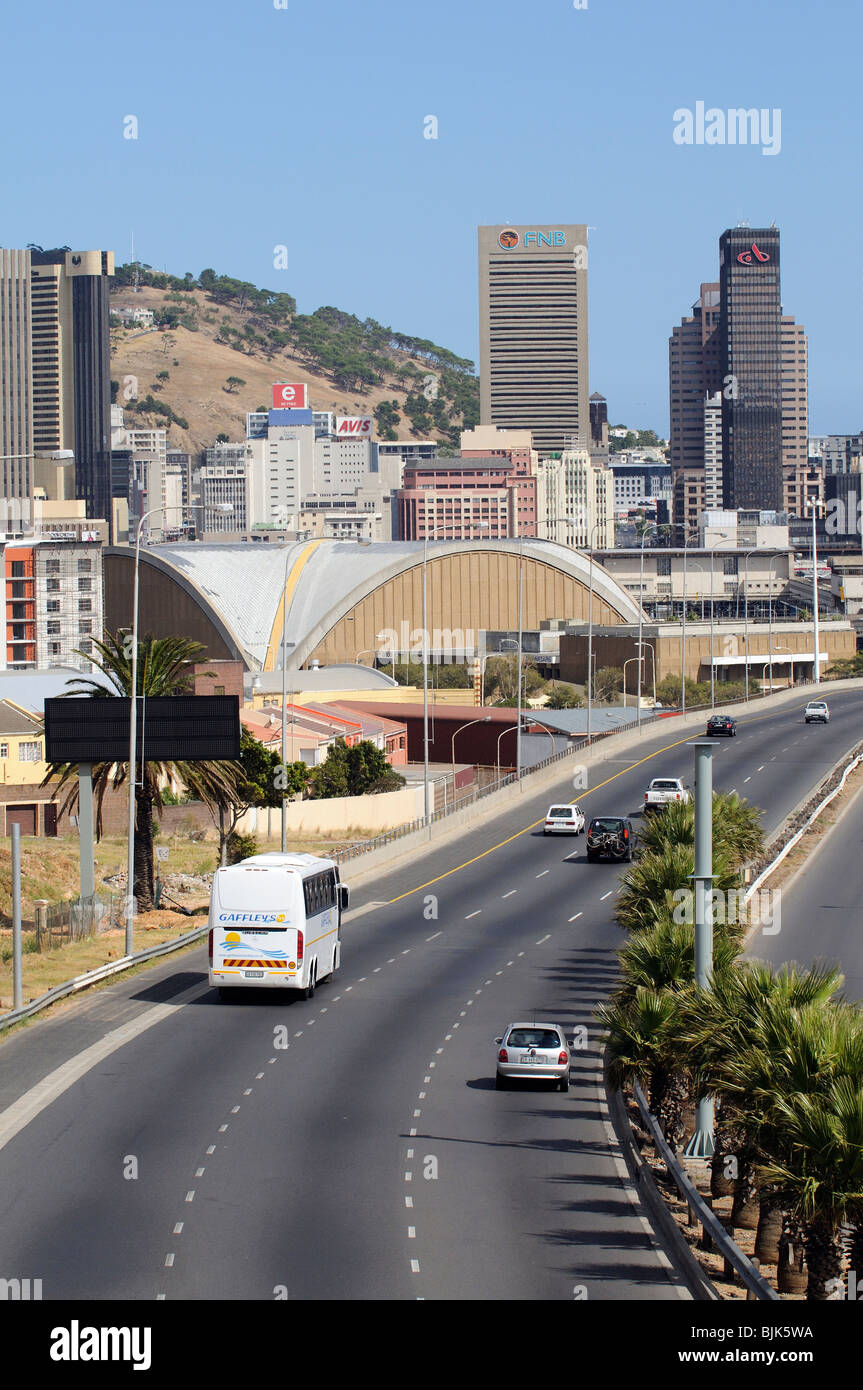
top-left (0, 692), bottom-right (863, 1301)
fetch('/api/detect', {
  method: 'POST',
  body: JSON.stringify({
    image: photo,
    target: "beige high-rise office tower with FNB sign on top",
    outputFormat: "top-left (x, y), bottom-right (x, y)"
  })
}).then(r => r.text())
top-left (479, 225), bottom-right (591, 456)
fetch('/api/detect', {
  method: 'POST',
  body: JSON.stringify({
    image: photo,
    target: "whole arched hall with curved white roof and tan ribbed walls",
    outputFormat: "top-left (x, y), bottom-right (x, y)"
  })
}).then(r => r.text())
top-left (104, 538), bottom-right (638, 671)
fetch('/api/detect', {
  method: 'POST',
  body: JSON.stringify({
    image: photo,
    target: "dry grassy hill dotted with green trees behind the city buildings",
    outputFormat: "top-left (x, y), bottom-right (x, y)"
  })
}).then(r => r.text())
top-left (111, 265), bottom-right (479, 453)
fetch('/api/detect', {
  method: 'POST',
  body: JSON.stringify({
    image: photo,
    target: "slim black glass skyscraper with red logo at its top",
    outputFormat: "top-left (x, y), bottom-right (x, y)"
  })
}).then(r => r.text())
top-left (718, 227), bottom-right (782, 512)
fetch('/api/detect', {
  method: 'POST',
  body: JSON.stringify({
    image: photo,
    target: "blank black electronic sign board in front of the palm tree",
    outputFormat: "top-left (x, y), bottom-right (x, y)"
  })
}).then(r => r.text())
top-left (44, 695), bottom-right (240, 763)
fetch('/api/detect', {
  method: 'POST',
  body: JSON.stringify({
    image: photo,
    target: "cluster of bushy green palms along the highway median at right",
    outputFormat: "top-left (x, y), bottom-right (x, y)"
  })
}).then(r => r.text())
top-left (598, 794), bottom-right (863, 1301)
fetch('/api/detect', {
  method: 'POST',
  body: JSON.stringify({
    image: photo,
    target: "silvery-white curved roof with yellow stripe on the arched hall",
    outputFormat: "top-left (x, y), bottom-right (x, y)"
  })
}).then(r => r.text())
top-left (140, 538), bottom-right (638, 670)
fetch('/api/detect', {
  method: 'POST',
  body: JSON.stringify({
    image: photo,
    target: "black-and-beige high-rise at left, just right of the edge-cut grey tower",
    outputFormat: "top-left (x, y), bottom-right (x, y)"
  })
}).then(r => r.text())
top-left (29, 247), bottom-right (114, 524)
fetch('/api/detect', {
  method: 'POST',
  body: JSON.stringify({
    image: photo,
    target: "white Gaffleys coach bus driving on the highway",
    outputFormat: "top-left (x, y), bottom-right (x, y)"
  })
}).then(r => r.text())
top-left (208, 853), bottom-right (349, 999)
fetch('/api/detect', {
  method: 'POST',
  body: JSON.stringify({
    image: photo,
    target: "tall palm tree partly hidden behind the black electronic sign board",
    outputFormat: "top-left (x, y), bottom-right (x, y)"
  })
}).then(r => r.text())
top-left (43, 631), bottom-right (236, 912)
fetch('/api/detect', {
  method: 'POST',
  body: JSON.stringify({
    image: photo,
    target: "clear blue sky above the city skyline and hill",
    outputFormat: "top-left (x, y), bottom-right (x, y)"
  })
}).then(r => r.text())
top-left (0, 0), bottom-right (863, 434)
